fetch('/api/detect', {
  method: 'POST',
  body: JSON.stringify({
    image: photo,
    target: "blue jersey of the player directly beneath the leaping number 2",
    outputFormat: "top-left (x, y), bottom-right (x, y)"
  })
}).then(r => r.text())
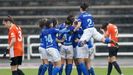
top-left (73, 28), bottom-right (83, 48)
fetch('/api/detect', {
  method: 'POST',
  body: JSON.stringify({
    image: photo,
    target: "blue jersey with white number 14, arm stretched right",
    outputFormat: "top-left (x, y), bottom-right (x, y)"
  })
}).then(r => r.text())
top-left (40, 28), bottom-right (70, 48)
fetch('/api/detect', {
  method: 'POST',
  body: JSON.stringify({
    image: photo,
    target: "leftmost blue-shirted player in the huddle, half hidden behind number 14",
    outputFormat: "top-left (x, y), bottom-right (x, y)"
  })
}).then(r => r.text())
top-left (38, 18), bottom-right (48, 75)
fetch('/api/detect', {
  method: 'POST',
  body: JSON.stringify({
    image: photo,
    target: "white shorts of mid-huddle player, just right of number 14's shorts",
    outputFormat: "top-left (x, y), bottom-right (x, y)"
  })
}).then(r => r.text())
top-left (60, 45), bottom-right (73, 59)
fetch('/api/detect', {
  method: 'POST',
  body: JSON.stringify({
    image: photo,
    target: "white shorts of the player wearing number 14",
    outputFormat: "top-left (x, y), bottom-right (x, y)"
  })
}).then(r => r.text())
top-left (46, 48), bottom-right (61, 62)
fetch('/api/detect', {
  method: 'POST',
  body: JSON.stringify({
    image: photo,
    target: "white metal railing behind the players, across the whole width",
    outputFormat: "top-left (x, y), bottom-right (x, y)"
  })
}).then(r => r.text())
top-left (0, 34), bottom-right (133, 60)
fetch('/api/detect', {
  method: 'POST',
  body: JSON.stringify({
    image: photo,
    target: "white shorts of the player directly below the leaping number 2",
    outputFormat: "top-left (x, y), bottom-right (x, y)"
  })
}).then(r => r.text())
top-left (76, 44), bottom-right (88, 58)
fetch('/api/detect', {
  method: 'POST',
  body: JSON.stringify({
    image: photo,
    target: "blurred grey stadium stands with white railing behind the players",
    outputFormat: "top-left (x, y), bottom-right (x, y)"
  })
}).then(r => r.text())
top-left (0, 0), bottom-right (133, 68)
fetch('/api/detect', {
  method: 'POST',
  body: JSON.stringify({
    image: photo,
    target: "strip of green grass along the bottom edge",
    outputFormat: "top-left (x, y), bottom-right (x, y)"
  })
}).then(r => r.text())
top-left (0, 68), bottom-right (133, 75)
